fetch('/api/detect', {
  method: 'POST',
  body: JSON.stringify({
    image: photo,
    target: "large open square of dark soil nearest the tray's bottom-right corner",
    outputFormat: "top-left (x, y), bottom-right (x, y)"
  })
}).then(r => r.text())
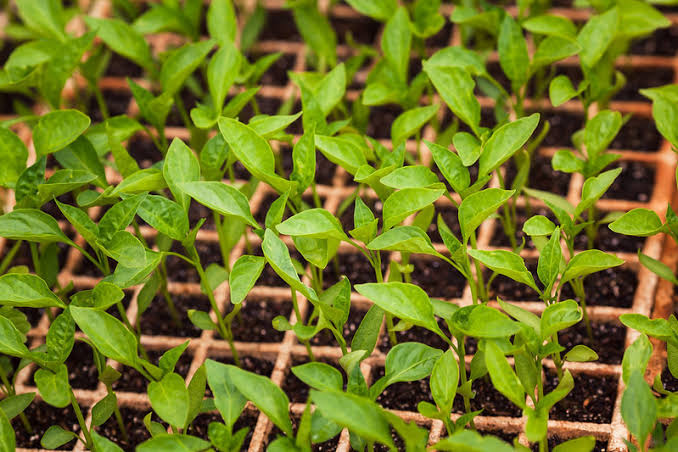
top-left (544, 371), bottom-right (618, 424)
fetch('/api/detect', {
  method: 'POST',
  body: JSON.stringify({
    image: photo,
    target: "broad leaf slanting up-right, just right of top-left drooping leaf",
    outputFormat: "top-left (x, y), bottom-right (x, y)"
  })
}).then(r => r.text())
top-left (160, 40), bottom-right (214, 95)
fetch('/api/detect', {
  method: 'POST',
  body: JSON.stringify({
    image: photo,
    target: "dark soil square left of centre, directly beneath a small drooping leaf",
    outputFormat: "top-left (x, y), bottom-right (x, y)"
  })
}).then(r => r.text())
top-left (231, 297), bottom-right (292, 342)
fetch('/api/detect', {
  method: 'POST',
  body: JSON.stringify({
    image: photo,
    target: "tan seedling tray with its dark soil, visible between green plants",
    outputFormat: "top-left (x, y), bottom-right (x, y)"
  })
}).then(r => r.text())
top-left (0, 0), bottom-right (678, 452)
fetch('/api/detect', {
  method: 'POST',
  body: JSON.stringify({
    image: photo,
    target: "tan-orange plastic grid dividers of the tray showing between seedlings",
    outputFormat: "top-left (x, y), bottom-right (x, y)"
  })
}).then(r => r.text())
top-left (0, 0), bottom-right (678, 451)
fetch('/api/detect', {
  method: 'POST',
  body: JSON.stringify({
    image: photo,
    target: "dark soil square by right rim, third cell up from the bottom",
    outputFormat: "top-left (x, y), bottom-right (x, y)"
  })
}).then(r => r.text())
top-left (560, 267), bottom-right (638, 308)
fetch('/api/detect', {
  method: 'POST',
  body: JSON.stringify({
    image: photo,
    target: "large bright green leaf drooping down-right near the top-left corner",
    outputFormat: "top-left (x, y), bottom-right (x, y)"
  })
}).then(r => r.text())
top-left (85, 16), bottom-right (153, 69)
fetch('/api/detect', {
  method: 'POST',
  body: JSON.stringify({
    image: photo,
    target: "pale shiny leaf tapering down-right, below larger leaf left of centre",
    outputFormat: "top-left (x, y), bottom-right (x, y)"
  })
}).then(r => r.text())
top-left (180, 181), bottom-right (259, 228)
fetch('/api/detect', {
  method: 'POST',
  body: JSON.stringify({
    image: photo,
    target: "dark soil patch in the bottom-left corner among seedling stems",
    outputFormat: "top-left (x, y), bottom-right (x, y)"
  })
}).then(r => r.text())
top-left (12, 401), bottom-right (87, 450)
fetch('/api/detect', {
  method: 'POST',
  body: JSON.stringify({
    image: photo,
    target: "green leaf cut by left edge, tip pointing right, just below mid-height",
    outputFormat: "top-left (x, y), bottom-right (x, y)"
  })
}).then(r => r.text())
top-left (0, 273), bottom-right (66, 308)
